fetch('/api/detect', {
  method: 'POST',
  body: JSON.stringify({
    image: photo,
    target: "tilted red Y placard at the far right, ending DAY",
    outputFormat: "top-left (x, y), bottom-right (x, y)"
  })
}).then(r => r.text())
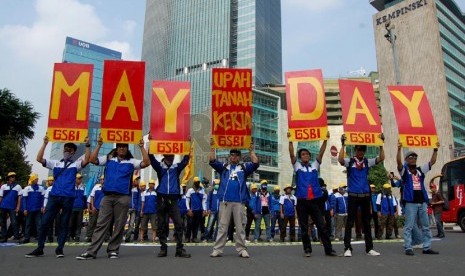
top-left (388, 86), bottom-right (438, 148)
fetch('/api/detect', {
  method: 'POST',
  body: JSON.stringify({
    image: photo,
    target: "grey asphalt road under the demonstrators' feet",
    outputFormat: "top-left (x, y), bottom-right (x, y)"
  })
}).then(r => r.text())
top-left (0, 230), bottom-right (465, 276)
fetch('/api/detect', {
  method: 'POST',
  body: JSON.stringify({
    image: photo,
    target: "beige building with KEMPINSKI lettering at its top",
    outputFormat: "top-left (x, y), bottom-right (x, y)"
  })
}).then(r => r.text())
top-left (370, 0), bottom-right (465, 176)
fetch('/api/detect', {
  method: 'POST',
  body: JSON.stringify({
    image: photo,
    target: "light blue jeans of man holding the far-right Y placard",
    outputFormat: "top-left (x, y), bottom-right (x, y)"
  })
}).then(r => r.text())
top-left (404, 202), bottom-right (432, 250)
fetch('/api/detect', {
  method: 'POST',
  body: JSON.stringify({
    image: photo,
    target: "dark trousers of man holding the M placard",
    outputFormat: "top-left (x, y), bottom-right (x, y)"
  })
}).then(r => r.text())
top-left (37, 195), bottom-right (74, 250)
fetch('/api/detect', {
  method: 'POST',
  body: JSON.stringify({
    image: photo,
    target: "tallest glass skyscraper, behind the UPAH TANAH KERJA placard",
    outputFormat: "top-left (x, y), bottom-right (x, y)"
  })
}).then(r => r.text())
top-left (142, 0), bottom-right (282, 183)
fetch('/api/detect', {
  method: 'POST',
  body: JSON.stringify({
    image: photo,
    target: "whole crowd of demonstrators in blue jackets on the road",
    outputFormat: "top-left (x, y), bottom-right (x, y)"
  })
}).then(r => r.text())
top-left (0, 134), bottom-right (445, 260)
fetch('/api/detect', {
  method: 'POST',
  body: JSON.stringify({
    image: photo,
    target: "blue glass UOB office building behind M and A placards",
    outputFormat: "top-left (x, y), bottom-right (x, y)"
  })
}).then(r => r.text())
top-left (50, 37), bottom-right (121, 183)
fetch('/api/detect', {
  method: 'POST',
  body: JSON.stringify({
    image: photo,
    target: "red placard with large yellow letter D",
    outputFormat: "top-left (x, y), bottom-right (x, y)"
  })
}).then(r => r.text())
top-left (285, 69), bottom-right (328, 141)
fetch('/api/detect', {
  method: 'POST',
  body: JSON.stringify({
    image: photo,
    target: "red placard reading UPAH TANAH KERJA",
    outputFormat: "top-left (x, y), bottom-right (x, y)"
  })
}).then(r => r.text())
top-left (212, 68), bottom-right (252, 148)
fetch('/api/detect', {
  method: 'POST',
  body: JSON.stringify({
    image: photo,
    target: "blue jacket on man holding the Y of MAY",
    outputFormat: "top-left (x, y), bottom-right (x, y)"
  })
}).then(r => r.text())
top-left (149, 154), bottom-right (189, 197)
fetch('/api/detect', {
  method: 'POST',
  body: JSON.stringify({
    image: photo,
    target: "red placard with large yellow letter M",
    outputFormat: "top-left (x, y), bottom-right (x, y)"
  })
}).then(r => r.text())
top-left (47, 63), bottom-right (94, 142)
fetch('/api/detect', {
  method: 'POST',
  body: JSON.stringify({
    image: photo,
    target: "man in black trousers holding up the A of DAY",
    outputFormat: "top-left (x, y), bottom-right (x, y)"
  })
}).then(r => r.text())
top-left (338, 134), bottom-right (384, 257)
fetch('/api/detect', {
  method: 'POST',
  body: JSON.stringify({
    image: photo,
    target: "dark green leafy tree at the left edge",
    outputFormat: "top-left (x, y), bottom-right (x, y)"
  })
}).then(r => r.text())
top-left (0, 88), bottom-right (40, 185)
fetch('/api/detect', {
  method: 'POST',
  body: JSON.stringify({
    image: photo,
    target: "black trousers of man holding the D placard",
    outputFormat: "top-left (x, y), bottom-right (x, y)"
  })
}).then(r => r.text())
top-left (296, 198), bottom-right (333, 254)
